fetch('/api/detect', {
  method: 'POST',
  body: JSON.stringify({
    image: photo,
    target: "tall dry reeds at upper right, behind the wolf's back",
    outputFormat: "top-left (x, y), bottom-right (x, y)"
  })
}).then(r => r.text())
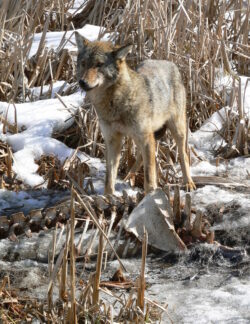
top-left (100, 0), bottom-right (250, 157)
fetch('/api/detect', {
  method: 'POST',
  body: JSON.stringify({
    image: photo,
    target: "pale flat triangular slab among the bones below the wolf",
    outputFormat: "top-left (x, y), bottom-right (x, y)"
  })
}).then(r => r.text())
top-left (125, 188), bottom-right (186, 252)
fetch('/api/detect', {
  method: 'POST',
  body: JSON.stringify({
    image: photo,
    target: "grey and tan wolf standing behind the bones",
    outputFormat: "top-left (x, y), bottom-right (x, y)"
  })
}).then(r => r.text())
top-left (75, 32), bottom-right (195, 194)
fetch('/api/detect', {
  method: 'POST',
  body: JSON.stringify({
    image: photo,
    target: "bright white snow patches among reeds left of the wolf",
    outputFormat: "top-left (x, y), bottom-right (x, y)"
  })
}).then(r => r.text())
top-left (0, 23), bottom-right (114, 187)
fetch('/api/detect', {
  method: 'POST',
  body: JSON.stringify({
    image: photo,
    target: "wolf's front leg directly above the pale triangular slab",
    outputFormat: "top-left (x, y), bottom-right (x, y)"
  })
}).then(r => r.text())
top-left (140, 133), bottom-right (157, 193)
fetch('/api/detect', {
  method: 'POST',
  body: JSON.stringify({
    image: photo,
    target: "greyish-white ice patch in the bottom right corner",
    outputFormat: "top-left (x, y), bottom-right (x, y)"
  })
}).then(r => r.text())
top-left (149, 274), bottom-right (250, 324)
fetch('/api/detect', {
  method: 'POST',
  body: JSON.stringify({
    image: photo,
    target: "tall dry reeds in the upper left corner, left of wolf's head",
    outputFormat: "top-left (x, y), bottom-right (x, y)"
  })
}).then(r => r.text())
top-left (0, 0), bottom-right (77, 102)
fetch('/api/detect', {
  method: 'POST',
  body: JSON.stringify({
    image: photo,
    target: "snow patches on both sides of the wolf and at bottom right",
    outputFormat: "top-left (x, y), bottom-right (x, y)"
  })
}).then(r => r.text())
top-left (0, 17), bottom-right (250, 323)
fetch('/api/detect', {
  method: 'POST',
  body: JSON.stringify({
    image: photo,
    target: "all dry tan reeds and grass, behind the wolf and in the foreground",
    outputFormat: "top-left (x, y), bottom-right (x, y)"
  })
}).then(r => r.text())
top-left (0, 0), bottom-right (250, 323)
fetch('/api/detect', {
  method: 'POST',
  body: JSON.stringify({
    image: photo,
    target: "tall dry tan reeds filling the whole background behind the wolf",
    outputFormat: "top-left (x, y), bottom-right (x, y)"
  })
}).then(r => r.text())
top-left (0, 0), bottom-right (250, 176)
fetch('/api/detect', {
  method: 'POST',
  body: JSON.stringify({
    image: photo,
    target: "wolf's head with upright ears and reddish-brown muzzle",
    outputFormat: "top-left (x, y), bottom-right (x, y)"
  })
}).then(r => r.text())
top-left (75, 32), bottom-right (132, 91)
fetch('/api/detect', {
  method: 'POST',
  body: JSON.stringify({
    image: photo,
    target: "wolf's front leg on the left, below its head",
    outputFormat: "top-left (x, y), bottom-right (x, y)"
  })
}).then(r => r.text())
top-left (104, 133), bottom-right (122, 195)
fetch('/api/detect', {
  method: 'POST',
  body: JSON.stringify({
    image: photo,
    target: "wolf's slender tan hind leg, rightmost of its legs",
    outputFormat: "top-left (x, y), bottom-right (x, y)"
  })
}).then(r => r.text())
top-left (168, 118), bottom-right (196, 190)
